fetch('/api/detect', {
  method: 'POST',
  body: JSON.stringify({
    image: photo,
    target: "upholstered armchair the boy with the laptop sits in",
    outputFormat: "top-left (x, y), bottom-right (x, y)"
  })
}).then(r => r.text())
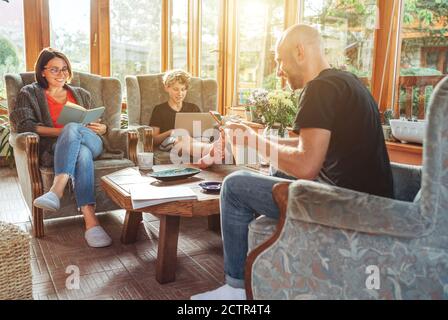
top-left (126, 73), bottom-right (218, 164)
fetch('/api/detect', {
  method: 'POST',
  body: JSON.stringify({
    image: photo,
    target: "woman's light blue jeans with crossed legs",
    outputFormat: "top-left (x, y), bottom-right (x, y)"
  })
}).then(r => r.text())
top-left (54, 122), bottom-right (103, 208)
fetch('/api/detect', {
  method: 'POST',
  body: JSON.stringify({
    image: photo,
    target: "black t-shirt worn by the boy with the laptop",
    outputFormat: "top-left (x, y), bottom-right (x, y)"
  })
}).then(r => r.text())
top-left (149, 102), bottom-right (201, 133)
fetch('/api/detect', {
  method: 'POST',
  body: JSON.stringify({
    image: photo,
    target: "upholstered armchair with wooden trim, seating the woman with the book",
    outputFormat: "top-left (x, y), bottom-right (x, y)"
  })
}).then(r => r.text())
top-left (5, 72), bottom-right (138, 237)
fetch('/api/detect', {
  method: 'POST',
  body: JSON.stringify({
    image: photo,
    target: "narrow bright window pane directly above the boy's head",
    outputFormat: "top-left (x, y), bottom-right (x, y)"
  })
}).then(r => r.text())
top-left (171, 0), bottom-right (188, 70)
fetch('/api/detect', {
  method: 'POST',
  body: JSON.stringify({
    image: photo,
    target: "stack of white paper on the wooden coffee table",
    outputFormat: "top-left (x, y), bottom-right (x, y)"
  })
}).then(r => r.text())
top-left (129, 183), bottom-right (198, 209)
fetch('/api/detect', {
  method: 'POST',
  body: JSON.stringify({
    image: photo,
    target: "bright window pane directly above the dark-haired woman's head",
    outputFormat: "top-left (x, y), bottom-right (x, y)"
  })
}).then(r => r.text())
top-left (49, 0), bottom-right (90, 72)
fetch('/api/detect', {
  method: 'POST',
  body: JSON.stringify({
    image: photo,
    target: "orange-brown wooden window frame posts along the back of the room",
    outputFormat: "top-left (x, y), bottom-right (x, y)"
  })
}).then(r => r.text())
top-left (23, 0), bottom-right (404, 114)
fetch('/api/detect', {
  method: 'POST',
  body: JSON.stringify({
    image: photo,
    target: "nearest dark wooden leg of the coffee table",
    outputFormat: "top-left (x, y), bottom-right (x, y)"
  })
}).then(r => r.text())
top-left (156, 215), bottom-right (180, 283)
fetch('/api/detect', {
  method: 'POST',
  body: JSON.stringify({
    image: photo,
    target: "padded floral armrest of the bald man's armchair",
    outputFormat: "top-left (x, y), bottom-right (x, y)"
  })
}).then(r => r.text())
top-left (287, 180), bottom-right (432, 238)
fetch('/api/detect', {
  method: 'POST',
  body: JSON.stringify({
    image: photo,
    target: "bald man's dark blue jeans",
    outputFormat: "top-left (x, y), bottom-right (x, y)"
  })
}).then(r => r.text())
top-left (221, 171), bottom-right (291, 288)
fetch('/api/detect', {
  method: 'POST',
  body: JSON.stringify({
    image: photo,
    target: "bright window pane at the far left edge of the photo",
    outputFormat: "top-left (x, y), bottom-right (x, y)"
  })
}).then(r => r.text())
top-left (0, 1), bottom-right (25, 98)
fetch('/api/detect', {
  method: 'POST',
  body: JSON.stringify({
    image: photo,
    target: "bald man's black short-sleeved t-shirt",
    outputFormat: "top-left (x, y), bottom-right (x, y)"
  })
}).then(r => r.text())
top-left (294, 69), bottom-right (393, 198)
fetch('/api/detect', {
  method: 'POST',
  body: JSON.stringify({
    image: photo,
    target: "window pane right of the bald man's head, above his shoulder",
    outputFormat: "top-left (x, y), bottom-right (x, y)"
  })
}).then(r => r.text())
top-left (304, 0), bottom-right (378, 85)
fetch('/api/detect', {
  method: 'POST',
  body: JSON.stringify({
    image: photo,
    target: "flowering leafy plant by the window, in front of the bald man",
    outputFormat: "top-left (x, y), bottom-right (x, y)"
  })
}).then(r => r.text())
top-left (249, 89), bottom-right (298, 136)
